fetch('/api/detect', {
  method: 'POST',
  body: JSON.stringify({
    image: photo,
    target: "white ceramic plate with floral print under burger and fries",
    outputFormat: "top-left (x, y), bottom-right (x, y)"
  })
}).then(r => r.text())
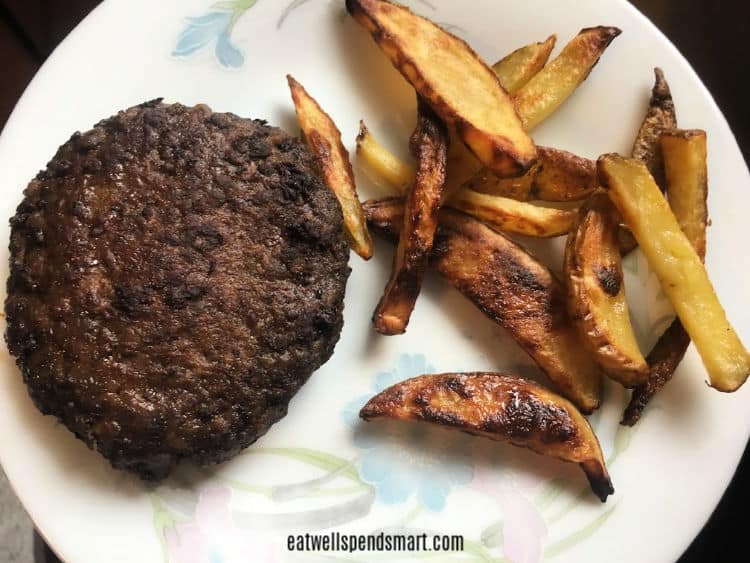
top-left (0, 0), bottom-right (750, 563)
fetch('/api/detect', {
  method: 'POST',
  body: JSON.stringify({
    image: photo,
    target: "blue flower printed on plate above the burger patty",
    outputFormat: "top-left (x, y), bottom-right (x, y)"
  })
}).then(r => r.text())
top-left (172, 1), bottom-right (250, 68)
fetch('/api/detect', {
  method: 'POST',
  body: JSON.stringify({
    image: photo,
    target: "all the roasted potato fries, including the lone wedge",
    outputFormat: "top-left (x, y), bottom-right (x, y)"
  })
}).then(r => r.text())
top-left (289, 0), bottom-right (750, 501)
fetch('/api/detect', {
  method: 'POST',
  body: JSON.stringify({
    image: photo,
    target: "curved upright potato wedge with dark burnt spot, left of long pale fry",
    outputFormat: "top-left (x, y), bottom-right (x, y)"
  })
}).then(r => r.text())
top-left (564, 193), bottom-right (648, 387)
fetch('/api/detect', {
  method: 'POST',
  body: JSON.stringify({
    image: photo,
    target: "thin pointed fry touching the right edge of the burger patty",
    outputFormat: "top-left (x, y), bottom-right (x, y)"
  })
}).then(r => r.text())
top-left (287, 75), bottom-right (372, 260)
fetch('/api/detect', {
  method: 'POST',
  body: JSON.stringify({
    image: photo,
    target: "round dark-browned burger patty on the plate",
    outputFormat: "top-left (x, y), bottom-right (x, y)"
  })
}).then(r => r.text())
top-left (5, 100), bottom-right (349, 479)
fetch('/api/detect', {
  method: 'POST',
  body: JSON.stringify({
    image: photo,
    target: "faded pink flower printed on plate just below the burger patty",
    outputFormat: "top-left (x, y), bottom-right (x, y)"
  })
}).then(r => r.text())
top-left (164, 487), bottom-right (276, 563)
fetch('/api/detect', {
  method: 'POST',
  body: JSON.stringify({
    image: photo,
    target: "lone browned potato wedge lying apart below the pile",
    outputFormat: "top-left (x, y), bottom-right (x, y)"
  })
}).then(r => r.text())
top-left (359, 373), bottom-right (614, 502)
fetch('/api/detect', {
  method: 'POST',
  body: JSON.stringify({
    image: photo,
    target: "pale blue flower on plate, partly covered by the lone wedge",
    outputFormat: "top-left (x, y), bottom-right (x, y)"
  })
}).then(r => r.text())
top-left (341, 354), bottom-right (473, 512)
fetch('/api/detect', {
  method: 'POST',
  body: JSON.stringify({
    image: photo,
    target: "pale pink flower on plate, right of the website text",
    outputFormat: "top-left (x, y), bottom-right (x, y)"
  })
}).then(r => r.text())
top-left (472, 461), bottom-right (547, 563)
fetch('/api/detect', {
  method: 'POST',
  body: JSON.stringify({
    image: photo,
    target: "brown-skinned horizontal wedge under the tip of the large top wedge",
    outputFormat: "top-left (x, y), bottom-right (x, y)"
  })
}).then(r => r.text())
top-left (465, 147), bottom-right (598, 202)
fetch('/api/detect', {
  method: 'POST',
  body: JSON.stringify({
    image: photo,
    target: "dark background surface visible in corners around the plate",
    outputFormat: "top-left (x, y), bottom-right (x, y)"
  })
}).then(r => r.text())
top-left (0, 0), bottom-right (750, 563)
